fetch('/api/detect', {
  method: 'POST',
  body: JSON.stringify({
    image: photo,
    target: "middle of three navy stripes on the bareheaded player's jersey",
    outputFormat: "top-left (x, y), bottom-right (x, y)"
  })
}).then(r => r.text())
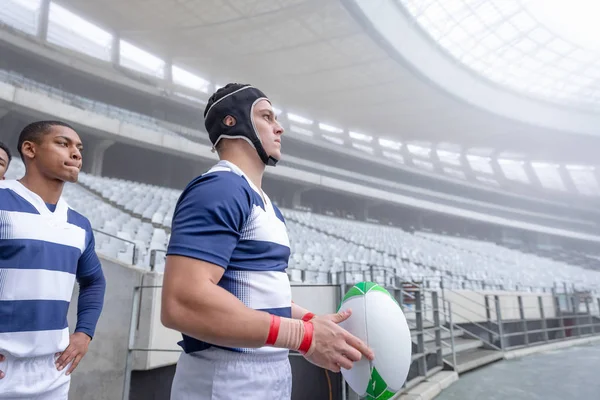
top-left (0, 239), bottom-right (81, 274)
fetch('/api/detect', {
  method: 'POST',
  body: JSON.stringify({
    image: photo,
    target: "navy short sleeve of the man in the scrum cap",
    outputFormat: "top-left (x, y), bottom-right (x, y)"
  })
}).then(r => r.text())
top-left (167, 171), bottom-right (251, 268)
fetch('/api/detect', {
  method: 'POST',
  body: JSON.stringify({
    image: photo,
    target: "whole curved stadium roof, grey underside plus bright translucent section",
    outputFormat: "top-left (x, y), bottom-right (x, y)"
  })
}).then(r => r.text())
top-left (24, 0), bottom-right (600, 163)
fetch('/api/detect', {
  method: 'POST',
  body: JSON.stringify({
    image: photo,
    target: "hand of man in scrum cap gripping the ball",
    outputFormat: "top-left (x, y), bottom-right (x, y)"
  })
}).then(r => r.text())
top-left (304, 310), bottom-right (375, 372)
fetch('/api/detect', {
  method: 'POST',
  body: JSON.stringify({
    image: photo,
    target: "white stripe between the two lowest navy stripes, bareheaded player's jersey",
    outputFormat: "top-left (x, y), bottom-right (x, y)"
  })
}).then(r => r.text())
top-left (0, 268), bottom-right (75, 302)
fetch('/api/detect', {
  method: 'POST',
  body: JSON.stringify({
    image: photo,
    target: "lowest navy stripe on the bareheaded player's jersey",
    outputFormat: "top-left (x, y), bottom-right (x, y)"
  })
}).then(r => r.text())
top-left (0, 300), bottom-right (69, 333)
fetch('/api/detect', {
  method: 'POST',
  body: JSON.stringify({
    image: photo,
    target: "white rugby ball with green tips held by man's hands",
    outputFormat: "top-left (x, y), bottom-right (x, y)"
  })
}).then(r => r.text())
top-left (338, 282), bottom-right (412, 400)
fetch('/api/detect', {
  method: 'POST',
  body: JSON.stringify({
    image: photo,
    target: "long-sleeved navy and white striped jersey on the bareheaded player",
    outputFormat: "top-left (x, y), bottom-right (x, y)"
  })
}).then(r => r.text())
top-left (0, 180), bottom-right (104, 357)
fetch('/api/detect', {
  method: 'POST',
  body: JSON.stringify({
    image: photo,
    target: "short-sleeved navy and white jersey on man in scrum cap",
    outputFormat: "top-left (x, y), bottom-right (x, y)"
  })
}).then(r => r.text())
top-left (167, 161), bottom-right (292, 354)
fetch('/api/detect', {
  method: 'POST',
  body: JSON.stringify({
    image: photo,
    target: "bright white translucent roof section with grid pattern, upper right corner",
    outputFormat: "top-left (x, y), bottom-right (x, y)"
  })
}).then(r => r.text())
top-left (398, 0), bottom-right (600, 111)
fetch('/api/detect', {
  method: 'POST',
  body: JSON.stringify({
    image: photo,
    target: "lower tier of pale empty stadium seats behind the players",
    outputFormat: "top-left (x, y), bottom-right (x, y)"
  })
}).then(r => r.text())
top-left (7, 160), bottom-right (600, 291)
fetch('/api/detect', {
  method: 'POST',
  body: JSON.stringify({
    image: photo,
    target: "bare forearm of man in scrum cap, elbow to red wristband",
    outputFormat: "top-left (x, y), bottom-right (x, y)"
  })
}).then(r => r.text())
top-left (161, 282), bottom-right (271, 348)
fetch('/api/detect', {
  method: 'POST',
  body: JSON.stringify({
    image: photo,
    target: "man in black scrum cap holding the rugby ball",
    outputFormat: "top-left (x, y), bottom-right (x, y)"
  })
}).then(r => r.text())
top-left (162, 83), bottom-right (373, 400)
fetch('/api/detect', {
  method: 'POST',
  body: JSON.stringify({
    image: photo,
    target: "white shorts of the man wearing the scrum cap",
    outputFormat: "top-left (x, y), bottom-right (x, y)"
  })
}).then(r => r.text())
top-left (171, 347), bottom-right (292, 400)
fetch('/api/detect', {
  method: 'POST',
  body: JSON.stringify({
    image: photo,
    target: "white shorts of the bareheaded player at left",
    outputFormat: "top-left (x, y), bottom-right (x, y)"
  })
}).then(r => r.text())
top-left (0, 353), bottom-right (71, 400)
